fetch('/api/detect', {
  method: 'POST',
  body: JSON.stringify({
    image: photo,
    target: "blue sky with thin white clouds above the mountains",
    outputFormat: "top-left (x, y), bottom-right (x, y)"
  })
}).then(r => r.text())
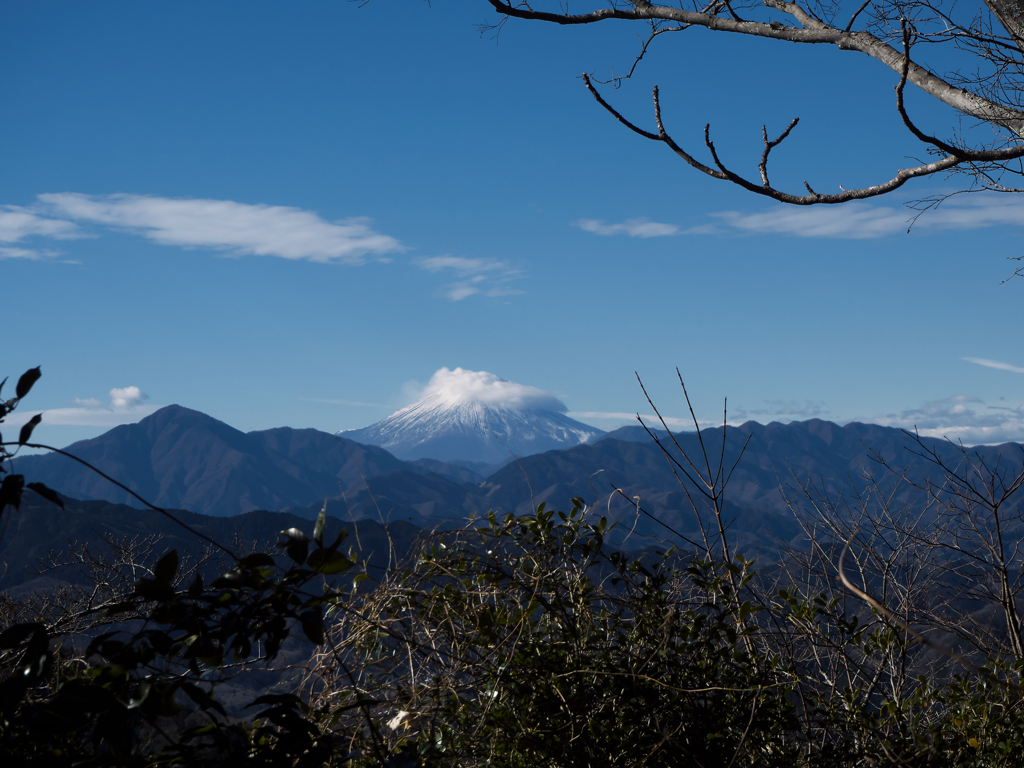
top-left (6, 0), bottom-right (1024, 444)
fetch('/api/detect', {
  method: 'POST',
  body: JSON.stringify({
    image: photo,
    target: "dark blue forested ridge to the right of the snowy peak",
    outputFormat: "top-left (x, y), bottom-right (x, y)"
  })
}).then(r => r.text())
top-left (481, 419), bottom-right (1022, 551)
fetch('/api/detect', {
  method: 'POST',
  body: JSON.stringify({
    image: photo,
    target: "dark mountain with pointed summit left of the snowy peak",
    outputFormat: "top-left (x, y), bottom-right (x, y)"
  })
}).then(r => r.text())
top-left (14, 406), bottom-right (471, 516)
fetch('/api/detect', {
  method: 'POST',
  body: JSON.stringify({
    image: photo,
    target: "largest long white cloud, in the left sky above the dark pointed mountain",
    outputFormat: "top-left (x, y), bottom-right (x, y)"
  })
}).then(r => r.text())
top-left (39, 193), bottom-right (404, 264)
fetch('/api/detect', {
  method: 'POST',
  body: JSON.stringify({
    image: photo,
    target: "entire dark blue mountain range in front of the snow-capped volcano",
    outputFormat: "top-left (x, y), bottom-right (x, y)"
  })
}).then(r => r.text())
top-left (13, 406), bottom-right (1021, 551)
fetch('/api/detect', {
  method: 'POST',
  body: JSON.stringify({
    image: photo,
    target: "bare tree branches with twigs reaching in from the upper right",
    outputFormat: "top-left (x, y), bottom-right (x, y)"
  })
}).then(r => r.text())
top-left (487, 0), bottom-right (1024, 206)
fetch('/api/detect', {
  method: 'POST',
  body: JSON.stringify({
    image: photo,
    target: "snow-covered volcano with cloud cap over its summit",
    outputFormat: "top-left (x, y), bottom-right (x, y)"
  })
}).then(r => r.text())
top-left (338, 368), bottom-right (604, 464)
